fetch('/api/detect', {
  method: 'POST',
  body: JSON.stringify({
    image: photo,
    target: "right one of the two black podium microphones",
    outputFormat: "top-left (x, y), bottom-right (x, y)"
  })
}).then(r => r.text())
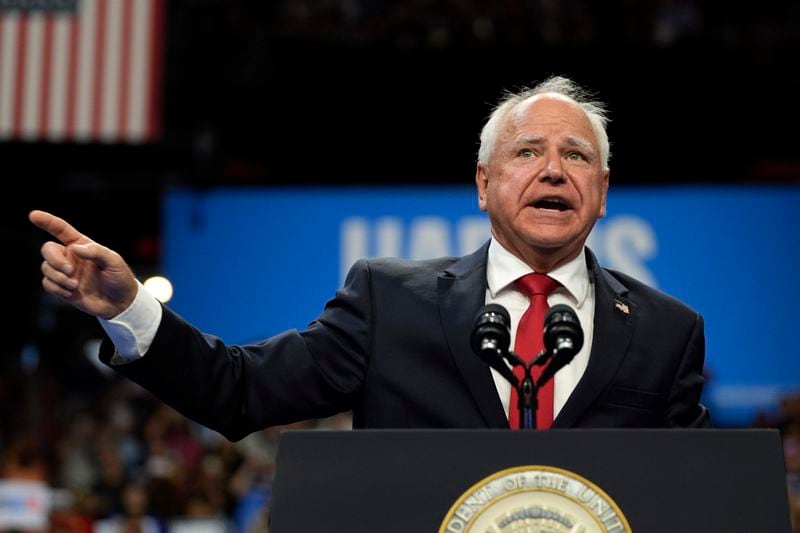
top-left (536, 304), bottom-right (583, 387)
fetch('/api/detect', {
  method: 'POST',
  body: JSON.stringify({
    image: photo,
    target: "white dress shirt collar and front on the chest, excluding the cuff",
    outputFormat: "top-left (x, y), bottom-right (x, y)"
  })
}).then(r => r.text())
top-left (486, 237), bottom-right (594, 418)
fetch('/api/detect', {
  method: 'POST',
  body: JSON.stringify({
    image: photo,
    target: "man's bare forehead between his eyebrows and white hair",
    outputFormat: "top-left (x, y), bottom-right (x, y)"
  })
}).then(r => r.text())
top-left (504, 94), bottom-right (597, 142)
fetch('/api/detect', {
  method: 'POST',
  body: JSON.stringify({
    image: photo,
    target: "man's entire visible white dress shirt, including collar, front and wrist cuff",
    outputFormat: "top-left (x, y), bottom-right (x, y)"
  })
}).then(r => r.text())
top-left (99, 238), bottom-right (594, 417)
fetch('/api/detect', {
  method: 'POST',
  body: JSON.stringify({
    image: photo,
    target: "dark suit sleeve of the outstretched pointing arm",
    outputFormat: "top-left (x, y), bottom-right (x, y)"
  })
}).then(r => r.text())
top-left (100, 261), bottom-right (372, 440)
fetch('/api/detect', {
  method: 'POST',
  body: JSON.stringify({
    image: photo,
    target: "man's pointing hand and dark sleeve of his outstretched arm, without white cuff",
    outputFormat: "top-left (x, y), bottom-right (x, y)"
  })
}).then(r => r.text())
top-left (29, 211), bottom-right (371, 440)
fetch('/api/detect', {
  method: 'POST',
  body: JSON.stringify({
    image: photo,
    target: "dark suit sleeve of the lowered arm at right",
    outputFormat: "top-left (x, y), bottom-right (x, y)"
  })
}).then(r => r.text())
top-left (664, 313), bottom-right (711, 428)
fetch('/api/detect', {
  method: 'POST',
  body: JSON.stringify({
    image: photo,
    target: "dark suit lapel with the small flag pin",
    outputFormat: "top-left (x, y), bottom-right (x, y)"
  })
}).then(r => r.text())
top-left (553, 248), bottom-right (636, 428)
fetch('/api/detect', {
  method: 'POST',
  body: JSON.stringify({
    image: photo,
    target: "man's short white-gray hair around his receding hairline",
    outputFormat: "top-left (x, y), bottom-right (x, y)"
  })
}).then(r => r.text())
top-left (478, 76), bottom-right (611, 170)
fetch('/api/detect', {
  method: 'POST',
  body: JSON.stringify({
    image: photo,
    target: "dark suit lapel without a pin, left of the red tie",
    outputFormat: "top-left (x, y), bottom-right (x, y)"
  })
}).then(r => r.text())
top-left (438, 243), bottom-right (508, 428)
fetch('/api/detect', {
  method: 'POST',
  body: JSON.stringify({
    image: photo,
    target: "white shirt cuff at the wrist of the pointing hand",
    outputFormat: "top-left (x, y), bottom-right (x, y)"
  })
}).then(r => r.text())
top-left (98, 281), bottom-right (163, 365)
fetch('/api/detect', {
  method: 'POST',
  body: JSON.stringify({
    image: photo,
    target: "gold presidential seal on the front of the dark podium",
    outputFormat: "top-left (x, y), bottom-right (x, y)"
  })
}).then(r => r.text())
top-left (439, 466), bottom-right (631, 533)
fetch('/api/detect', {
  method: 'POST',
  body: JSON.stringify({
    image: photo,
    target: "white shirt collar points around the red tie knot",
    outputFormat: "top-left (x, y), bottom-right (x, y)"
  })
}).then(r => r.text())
top-left (486, 237), bottom-right (589, 308)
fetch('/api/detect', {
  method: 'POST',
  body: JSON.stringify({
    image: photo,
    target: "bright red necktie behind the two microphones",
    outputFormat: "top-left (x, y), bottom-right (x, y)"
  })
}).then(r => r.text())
top-left (508, 272), bottom-right (559, 429)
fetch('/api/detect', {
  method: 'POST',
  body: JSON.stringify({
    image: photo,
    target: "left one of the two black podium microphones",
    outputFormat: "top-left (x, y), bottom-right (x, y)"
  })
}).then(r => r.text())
top-left (470, 304), bottom-right (519, 384)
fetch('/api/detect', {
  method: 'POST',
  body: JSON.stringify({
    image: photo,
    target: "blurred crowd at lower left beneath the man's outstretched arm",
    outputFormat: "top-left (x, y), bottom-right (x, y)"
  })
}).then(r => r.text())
top-left (0, 322), bottom-right (352, 533)
